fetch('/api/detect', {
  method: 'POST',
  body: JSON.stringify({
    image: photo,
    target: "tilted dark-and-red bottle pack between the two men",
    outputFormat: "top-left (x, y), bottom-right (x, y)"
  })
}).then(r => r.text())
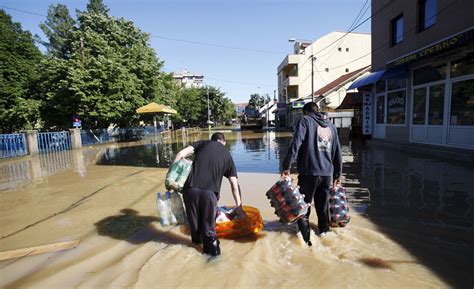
top-left (266, 178), bottom-right (309, 224)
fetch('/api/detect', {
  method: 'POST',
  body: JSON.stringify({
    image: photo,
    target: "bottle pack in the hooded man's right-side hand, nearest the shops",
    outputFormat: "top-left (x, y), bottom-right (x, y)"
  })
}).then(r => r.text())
top-left (329, 186), bottom-right (351, 227)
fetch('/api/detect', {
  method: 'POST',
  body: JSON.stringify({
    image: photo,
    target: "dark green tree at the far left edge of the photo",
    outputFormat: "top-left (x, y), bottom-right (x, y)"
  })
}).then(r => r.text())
top-left (0, 10), bottom-right (42, 132)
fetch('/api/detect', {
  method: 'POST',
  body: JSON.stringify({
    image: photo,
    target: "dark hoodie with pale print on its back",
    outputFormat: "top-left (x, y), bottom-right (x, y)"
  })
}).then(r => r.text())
top-left (282, 112), bottom-right (342, 179)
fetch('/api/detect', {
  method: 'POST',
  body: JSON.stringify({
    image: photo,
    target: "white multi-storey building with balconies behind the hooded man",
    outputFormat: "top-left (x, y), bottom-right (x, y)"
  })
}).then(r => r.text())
top-left (278, 31), bottom-right (371, 107)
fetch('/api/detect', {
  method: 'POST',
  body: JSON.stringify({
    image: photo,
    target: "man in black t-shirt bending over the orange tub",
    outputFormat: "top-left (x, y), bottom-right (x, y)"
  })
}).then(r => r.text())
top-left (175, 132), bottom-right (245, 256)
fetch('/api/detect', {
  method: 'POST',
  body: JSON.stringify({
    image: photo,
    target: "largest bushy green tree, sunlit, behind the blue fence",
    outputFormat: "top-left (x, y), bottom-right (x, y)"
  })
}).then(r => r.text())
top-left (40, 0), bottom-right (175, 127)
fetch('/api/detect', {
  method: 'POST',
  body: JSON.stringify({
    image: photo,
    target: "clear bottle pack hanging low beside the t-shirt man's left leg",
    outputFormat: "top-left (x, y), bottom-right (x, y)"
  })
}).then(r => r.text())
top-left (156, 191), bottom-right (186, 226)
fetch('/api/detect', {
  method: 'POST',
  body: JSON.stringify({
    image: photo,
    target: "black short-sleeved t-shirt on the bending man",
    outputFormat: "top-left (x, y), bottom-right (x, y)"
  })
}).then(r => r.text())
top-left (184, 140), bottom-right (237, 194)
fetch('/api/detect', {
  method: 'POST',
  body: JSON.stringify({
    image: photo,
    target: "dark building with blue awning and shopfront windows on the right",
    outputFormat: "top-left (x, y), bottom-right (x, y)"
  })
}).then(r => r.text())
top-left (351, 0), bottom-right (474, 149)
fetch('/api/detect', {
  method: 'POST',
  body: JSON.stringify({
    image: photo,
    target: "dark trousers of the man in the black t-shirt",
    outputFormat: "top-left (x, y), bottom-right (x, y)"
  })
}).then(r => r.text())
top-left (183, 188), bottom-right (217, 243)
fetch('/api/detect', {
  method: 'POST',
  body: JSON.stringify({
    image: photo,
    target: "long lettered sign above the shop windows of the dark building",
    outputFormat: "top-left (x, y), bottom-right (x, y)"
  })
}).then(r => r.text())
top-left (387, 29), bottom-right (474, 68)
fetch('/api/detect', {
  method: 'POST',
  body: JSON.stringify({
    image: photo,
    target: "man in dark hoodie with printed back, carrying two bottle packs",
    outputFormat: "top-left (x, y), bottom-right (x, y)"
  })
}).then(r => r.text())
top-left (281, 102), bottom-right (342, 246)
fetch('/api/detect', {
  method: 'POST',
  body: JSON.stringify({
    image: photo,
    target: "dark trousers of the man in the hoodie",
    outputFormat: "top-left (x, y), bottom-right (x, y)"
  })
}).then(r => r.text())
top-left (298, 175), bottom-right (332, 232)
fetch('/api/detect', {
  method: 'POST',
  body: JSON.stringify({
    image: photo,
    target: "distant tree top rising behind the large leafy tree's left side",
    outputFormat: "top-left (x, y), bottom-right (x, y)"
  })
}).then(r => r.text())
top-left (40, 4), bottom-right (76, 59)
